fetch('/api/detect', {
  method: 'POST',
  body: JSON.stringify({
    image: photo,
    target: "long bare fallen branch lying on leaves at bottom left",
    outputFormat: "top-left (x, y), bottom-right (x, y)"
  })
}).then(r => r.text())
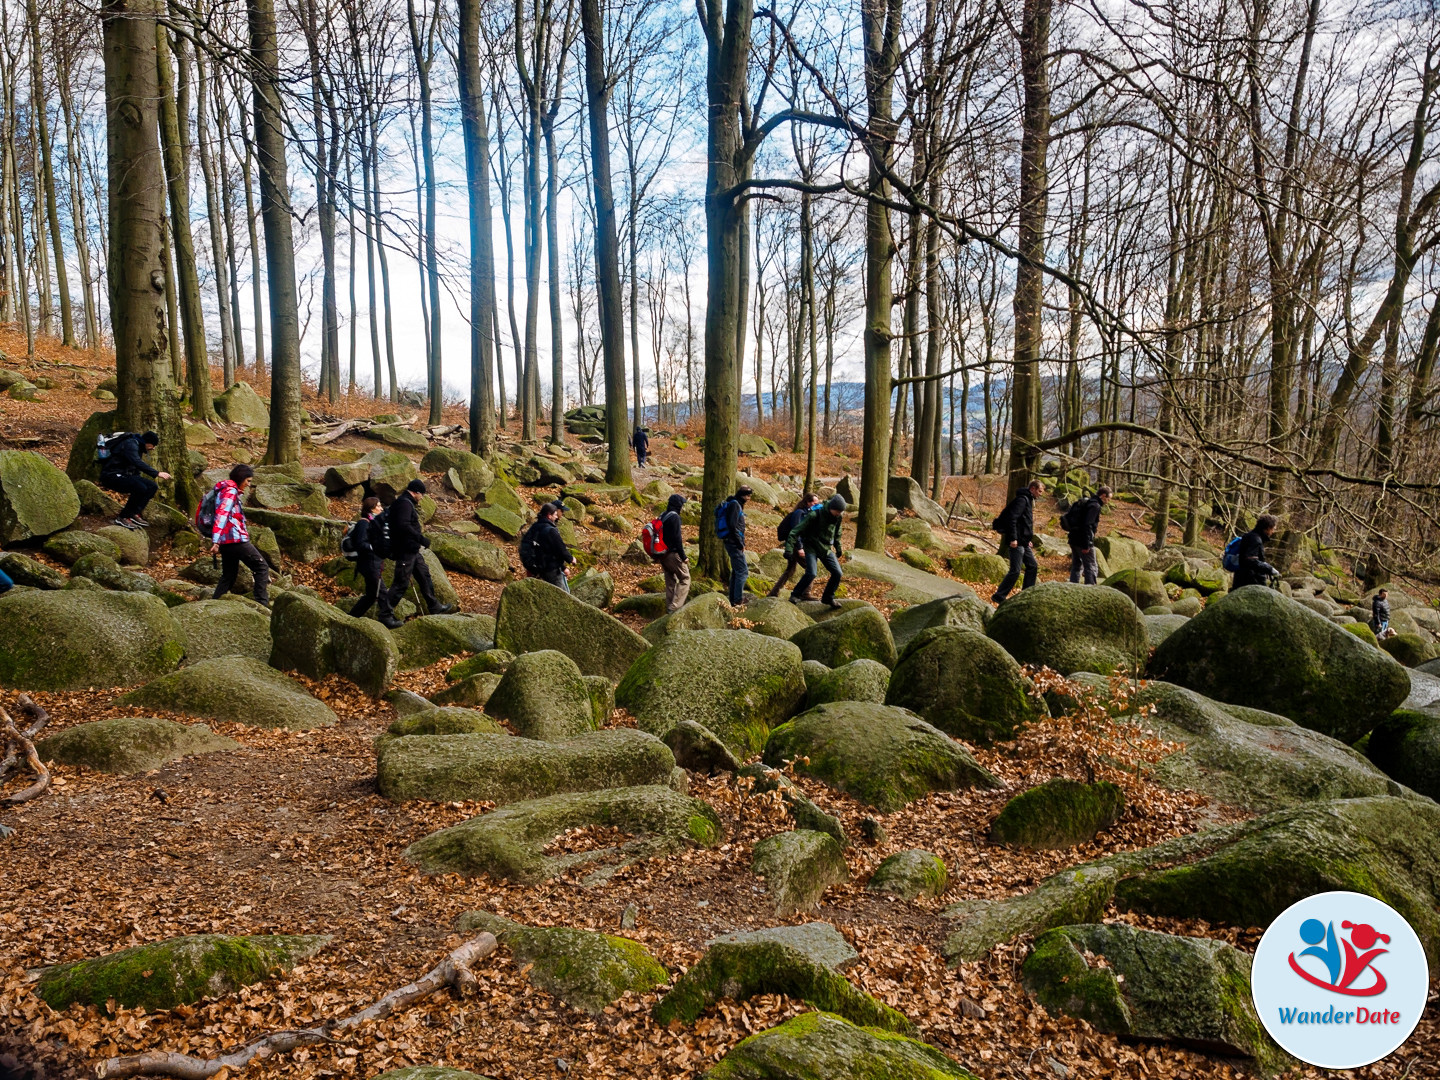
top-left (95, 933), bottom-right (495, 1080)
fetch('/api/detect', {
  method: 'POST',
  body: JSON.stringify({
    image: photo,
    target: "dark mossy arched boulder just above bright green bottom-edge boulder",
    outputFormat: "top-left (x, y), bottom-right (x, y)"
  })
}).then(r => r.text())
top-left (654, 935), bottom-right (914, 1034)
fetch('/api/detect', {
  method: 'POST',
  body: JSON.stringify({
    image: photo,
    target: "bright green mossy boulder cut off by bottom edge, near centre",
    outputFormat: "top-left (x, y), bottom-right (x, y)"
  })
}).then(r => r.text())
top-left (704, 1012), bottom-right (976, 1080)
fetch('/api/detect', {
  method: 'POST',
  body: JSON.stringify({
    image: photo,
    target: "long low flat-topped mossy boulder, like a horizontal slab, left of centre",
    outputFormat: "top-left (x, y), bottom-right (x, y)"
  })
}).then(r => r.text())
top-left (376, 728), bottom-right (675, 805)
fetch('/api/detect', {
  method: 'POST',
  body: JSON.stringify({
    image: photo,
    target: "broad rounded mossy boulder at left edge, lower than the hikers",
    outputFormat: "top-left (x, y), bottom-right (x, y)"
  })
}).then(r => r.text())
top-left (0, 589), bottom-right (184, 690)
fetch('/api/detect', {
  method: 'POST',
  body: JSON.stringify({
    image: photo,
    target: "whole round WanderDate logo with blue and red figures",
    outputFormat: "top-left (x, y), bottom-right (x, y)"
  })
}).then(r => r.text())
top-left (1250, 893), bottom-right (1430, 1068)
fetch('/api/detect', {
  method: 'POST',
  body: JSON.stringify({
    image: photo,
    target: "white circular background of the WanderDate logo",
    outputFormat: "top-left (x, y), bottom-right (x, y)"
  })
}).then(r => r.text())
top-left (1250, 893), bottom-right (1430, 1068)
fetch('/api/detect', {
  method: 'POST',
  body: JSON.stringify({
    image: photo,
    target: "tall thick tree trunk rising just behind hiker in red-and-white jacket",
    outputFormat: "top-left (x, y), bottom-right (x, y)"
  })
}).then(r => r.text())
top-left (246, 0), bottom-right (300, 465)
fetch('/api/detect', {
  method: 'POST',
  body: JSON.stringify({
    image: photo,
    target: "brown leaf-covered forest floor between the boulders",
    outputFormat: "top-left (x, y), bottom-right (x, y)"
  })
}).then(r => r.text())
top-left (0, 328), bottom-right (1440, 1080)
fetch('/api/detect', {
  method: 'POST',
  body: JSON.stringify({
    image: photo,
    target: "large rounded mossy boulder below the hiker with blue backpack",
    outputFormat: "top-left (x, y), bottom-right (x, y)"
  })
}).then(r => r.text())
top-left (615, 629), bottom-right (805, 756)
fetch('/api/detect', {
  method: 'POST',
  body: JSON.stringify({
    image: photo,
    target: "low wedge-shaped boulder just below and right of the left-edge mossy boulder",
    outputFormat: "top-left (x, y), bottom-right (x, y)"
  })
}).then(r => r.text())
top-left (117, 657), bottom-right (336, 732)
